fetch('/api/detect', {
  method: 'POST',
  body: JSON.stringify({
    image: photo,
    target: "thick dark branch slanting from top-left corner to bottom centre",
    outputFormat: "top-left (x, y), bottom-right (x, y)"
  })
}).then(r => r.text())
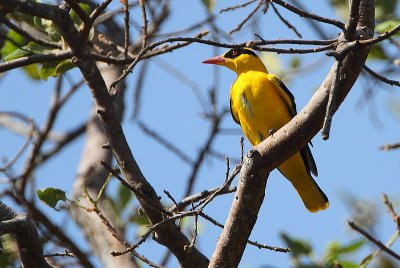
top-left (0, 0), bottom-right (208, 267)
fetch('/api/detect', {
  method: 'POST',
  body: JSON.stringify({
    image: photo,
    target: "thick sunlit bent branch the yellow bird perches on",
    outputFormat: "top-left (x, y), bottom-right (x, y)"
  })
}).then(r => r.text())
top-left (209, 0), bottom-right (374, 267)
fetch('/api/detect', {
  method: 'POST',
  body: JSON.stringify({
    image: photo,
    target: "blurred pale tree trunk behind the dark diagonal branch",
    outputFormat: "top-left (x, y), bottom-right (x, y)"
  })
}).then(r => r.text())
top-left (70, 63), bottom-right (137, 267)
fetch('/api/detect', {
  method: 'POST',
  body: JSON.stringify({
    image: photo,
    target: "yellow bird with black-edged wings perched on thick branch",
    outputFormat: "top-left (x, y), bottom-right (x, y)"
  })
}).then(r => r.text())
top-left (203, 48), bottom-right (329, 212)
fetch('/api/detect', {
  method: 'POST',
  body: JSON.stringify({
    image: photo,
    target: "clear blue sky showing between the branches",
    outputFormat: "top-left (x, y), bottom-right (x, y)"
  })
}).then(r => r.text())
top-left (0, 1), bottom-right (400, 267)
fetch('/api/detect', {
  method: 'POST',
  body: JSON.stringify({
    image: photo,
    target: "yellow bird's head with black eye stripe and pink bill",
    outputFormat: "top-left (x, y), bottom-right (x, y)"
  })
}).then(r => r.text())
top-left (203, 48), bottom-right (267, 74)
